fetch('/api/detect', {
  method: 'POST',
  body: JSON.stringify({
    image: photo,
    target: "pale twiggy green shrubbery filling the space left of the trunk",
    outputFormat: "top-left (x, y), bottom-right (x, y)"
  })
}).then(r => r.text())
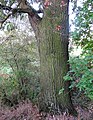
top-left (0, 31), bottom-right (40, 105)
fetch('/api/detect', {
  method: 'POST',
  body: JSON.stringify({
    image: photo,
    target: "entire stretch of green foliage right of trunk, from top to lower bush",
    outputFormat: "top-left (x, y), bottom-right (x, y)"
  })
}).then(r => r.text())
top-left (64, 0), bottom-right (93, 99)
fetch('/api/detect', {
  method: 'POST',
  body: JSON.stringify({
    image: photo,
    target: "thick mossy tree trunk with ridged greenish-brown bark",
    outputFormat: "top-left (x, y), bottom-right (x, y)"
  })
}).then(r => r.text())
top-left (29, 0), bottom-right (75, 114)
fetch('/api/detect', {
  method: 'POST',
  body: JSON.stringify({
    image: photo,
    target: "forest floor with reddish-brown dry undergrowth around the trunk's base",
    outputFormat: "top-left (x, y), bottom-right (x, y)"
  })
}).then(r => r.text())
top-left (0, 94), bottom-right (93, 120)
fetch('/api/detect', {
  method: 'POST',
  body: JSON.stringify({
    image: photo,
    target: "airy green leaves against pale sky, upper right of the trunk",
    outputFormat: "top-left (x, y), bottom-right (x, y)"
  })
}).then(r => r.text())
top-left (72, 0), bottom-right (93, 49)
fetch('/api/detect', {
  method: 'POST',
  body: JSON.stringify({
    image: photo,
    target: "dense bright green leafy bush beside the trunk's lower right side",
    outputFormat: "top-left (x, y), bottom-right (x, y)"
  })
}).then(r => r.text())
top-left (64, 52), bottom-right (93, 99)
